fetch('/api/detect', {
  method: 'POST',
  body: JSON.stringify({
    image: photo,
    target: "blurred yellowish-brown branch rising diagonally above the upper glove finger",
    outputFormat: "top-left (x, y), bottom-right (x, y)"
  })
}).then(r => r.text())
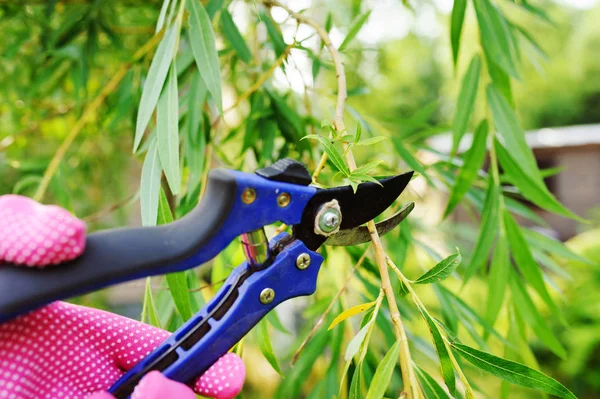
top-left (34, 31), bottom-right (163, 201)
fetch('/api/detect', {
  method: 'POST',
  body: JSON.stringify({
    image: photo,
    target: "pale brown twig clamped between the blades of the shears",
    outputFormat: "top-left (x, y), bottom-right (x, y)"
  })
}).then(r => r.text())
top-left (264, 0), bottom-right (419, 399)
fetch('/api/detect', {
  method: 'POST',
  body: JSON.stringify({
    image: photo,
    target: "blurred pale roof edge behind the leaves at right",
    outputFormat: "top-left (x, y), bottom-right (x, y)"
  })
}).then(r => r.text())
top-left (429, 124), bottom-right (600, 153)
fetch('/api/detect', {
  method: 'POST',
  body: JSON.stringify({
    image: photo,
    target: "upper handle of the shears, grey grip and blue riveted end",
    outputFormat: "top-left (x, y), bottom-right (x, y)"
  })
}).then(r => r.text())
top-left (0, 169), bottom-right (316, 323)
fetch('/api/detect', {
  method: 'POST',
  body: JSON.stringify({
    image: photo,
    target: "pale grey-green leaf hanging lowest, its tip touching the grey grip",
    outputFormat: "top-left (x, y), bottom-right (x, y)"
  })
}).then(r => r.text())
top-left (140, 139), bottom-right (162, 226)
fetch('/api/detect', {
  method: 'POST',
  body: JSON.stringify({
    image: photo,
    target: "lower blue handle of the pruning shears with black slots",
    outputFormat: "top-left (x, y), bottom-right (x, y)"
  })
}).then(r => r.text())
top-left (110, 233), bottom-right (323, 399)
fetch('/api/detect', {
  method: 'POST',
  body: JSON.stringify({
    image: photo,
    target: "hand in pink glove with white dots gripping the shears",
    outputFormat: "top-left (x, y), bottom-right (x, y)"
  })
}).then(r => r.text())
top-left (0, 195), bottom-right (246, 399)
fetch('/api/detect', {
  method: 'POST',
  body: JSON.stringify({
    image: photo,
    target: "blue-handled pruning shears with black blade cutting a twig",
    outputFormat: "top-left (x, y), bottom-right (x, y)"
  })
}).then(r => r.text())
top-left (0, 159), bottom-right (414, 399)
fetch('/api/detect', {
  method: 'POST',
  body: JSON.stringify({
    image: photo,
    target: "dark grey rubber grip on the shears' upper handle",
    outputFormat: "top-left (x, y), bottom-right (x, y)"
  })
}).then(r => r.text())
top-left (0, 169), bottom-right (237, 322)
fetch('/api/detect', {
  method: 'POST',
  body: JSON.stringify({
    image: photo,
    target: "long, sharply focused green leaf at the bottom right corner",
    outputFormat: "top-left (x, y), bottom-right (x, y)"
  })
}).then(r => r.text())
top-left (452, 343), bottom-right (577, 399)
